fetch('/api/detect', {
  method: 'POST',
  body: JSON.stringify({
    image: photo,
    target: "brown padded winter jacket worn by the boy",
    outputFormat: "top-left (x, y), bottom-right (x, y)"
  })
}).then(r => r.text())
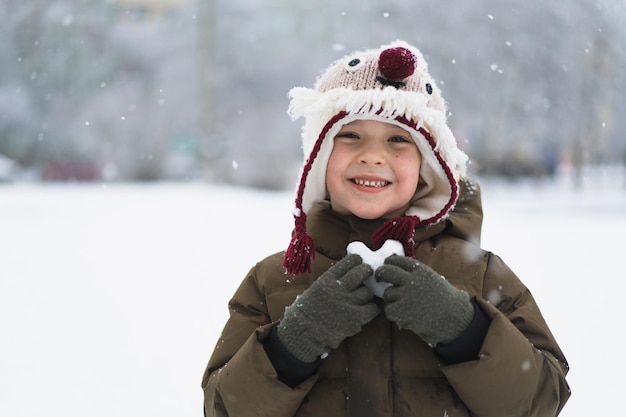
top-left (202, 184), bottom-right (569, 417)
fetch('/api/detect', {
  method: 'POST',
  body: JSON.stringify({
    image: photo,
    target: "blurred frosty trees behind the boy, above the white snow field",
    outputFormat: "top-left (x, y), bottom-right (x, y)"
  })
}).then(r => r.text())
top-left (0, 0), bottom-right (626, 189)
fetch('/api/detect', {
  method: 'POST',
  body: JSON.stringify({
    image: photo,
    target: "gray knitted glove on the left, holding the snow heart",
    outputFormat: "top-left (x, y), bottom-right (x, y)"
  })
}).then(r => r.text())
top-left (277, 255), bottom-right (378, 363)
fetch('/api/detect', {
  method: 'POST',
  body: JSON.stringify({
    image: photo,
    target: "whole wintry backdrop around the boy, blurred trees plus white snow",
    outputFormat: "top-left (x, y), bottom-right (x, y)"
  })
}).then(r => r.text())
top-left (0, 0), bottom-right (626, 417)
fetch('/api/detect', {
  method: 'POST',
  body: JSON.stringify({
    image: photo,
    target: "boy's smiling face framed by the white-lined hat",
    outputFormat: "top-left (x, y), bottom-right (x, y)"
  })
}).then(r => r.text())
top-left (326, 120), bottom-right (422, 219)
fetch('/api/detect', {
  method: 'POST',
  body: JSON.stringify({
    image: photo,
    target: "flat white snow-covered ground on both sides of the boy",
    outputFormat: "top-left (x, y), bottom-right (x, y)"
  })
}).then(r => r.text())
top-left (0, 167), bottom-right (626, 417)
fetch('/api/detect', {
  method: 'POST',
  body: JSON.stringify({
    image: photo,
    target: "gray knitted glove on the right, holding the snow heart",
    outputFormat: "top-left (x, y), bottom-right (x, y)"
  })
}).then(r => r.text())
top-left (376, 255), bottom-right (474, 346)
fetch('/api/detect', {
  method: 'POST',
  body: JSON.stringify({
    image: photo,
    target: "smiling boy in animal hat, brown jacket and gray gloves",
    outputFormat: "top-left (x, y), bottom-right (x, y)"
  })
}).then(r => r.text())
top-left (202, 41), bottom-right (569, 417)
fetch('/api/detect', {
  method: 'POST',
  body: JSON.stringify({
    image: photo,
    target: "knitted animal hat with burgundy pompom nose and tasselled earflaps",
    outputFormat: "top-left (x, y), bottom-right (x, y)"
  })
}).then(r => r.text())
top-left (283, 41), bottom-right (467, 274)
